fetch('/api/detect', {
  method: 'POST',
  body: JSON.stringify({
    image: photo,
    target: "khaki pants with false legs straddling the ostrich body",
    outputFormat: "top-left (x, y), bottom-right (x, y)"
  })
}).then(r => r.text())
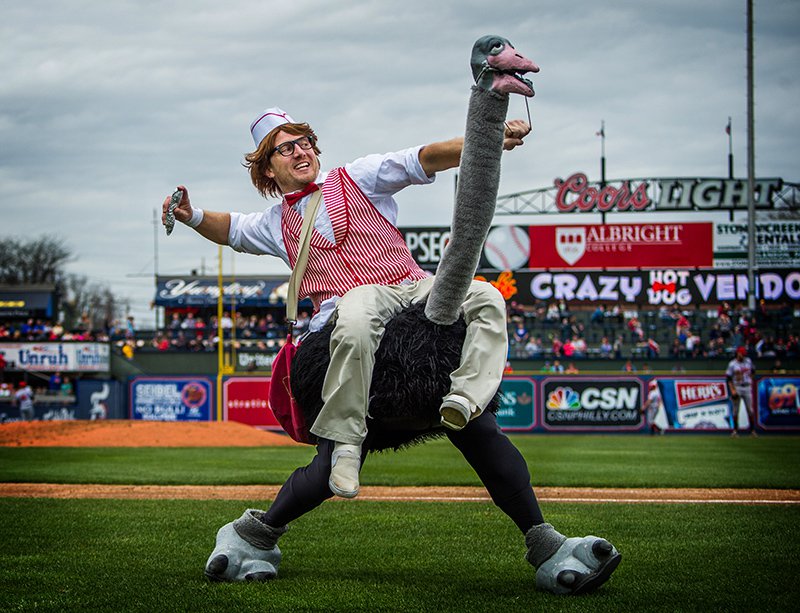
top-left (311, 277), bottom-right (508, 445)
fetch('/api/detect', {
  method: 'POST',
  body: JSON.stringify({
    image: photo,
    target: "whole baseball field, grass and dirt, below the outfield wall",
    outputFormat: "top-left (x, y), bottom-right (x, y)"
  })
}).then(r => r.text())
top-left (0, 422), bottom-right (800, 612)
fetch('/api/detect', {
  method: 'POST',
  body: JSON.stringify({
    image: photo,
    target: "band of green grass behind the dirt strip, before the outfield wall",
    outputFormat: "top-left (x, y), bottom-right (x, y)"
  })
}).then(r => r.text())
top-left (0, 435), bottom-right (800, 489)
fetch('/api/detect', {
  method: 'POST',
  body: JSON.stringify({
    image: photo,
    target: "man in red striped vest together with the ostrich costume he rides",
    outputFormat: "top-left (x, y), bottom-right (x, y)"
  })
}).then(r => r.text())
top-left (164, 36), bottom-right (621, 594)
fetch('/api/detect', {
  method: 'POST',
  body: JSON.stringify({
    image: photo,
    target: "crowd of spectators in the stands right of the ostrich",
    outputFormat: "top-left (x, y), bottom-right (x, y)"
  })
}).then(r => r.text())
top-left (508, 300), bottom-right (800, 366)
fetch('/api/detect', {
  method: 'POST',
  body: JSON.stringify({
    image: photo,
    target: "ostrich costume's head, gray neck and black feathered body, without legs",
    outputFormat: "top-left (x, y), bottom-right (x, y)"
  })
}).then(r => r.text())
top-left (291, 36), bottom-right (539, 450)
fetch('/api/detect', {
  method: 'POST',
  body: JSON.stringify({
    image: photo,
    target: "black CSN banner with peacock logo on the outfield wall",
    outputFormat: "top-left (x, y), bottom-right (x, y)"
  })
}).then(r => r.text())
top-left (540, 376), bottom-right (642, 431)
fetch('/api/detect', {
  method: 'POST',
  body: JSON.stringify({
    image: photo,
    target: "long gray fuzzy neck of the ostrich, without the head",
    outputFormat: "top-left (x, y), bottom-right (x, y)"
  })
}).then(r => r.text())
top-left (425, 86), bottom-right (508, 325)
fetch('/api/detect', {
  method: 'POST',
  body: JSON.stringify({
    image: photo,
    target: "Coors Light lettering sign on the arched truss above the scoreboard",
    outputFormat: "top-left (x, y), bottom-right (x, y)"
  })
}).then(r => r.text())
top-left (554, 172), bottom-right (783, 213)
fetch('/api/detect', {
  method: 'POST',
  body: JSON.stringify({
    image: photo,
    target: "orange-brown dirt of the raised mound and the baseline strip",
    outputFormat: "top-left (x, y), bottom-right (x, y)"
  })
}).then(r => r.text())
top-left (0, 420), bottom-right (800, 504)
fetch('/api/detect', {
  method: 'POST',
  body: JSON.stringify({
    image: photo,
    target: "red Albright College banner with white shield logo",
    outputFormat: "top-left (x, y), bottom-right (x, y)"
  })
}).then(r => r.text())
top-left (528, 222), bottom-right (714, 270)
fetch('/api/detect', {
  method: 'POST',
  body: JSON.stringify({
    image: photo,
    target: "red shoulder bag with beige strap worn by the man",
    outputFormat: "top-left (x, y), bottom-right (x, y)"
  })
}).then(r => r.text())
top-left (269, 190), bottom-right (322, 444)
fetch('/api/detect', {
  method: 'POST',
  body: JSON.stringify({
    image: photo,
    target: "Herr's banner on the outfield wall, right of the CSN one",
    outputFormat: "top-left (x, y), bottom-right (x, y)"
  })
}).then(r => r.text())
top-left (656, 377), bottom-right (732, 430)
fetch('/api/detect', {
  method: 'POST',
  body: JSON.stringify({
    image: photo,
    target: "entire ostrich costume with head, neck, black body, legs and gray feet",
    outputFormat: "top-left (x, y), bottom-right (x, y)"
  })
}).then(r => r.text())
top-left (205, 36), bottom-right (620, 594)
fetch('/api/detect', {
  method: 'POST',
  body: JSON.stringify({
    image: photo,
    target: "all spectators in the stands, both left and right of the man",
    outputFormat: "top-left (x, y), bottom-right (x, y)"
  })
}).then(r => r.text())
top-left (0, 300), bottom-right (800, 372)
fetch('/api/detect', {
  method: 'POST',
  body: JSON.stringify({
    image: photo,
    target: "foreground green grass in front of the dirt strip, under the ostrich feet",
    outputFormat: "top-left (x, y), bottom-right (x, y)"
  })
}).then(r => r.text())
top-left (0, 499), bottom-right (800, 613)
